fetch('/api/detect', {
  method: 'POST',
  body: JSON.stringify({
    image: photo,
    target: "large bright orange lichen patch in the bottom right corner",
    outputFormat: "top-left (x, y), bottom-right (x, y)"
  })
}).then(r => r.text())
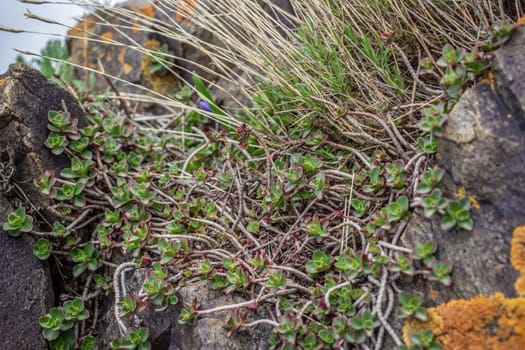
top-left (403, 293), bottom-right (525, 350)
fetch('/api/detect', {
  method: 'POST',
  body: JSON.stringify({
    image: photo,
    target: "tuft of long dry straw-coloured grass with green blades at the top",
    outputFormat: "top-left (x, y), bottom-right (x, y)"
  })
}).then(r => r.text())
top-left (50, 0), bottom-right (523, 144)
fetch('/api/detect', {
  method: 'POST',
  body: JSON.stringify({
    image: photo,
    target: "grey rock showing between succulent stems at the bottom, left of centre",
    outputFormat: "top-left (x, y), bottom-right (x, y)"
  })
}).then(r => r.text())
top-left (97, 269), bottom-right (271, 350)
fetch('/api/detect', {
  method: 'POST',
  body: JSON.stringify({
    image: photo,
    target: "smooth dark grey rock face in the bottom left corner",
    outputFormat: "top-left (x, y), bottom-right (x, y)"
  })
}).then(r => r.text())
top-left (0, 194), bottom-right (54, 350)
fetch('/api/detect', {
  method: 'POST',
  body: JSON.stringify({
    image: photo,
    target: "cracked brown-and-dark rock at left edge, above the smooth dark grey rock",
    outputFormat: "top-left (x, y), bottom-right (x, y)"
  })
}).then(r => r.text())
top-left (0, 64), bottom-right (84, 215)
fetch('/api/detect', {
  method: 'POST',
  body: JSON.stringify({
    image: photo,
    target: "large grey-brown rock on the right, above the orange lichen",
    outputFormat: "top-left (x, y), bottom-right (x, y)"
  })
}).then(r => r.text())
top-left (403, 27), bottom-right (525, 306)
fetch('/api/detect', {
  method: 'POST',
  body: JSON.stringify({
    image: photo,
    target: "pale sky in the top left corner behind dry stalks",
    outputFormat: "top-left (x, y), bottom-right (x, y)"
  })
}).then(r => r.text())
top-left (0, 0), bottom-right (123, 74)
